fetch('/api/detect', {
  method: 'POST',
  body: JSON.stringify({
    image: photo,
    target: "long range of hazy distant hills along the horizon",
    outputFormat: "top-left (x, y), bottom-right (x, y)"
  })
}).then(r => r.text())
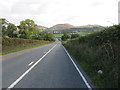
top-left (45, 24), bottom-right (105, 33)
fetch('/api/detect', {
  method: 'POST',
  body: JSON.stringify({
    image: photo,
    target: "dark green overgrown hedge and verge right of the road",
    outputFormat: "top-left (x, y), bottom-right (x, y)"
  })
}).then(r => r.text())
top-left (63, 25), bottom-right (120, 88)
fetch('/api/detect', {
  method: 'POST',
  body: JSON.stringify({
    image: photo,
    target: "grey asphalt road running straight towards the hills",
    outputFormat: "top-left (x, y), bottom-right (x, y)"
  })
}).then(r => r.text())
top-left (2, 41), bottom-right (89, 88)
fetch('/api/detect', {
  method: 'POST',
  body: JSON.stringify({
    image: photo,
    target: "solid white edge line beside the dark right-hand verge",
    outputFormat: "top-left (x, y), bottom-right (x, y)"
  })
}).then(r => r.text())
top-left (63, 46), bottom-right (92, 90)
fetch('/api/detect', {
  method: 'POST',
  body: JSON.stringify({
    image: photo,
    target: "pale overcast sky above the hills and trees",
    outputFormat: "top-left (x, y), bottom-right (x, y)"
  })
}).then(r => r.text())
top-left (0, 0), bottom-right (120, 27)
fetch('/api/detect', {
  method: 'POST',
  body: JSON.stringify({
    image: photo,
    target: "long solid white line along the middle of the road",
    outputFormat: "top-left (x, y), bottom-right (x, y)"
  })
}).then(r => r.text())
top-left (6, 44), bottom-right (57, 90)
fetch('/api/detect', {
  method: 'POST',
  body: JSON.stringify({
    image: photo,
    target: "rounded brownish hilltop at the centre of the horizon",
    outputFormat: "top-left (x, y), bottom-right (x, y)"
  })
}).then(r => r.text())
top-left (49, 24), bottom-right (75, 30)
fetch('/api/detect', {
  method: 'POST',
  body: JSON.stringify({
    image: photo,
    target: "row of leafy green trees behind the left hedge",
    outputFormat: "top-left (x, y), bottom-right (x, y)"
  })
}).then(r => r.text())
top-left (0, 18), bottom-right (54, 41)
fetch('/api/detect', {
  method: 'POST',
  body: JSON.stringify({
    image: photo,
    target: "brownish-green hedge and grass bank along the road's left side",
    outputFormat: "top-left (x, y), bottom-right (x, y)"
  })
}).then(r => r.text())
top-left (0, 38), bottom-right (52, 55)
